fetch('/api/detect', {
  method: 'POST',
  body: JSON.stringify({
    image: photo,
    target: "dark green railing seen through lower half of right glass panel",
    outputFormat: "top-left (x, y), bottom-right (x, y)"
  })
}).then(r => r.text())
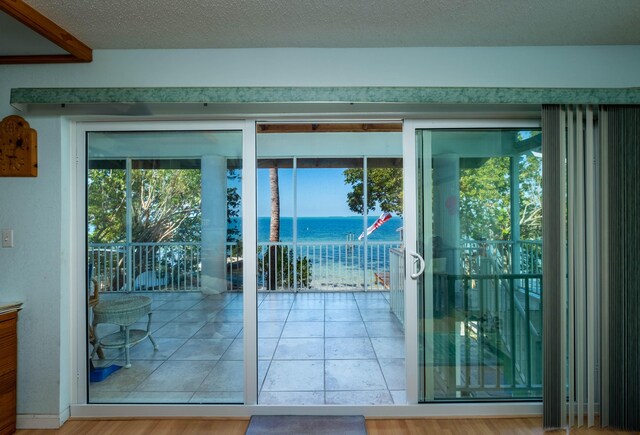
top-left (434, 274), bottom-right (542, 397)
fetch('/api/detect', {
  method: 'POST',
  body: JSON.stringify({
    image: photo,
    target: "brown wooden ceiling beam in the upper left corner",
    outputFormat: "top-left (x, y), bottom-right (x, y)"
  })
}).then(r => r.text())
top-left (0, 0), bottom-right (93, 64)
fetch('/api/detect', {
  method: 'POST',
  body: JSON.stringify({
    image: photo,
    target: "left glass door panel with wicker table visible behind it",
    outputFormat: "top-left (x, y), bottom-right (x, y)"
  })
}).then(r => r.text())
top-left (86, 131), bottom-right (244, 403)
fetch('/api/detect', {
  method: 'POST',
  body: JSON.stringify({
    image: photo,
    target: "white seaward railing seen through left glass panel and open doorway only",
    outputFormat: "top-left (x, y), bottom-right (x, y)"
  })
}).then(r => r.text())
top-left (88, 241), bottom-right (400, 292)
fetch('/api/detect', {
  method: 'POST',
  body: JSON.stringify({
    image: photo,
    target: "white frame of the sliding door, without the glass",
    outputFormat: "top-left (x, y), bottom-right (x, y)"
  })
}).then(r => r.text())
top-left (70, 116), bottom-right (542, 418)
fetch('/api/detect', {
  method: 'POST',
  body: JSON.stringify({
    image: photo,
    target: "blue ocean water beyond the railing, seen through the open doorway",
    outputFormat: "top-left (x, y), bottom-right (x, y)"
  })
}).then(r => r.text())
top-left (258, 215), bottom-right (402, 242)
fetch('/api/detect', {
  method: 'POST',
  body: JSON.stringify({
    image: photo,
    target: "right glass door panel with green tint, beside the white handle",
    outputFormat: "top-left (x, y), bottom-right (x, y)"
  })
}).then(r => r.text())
top-left (416, 129), bottom-right (542, 401)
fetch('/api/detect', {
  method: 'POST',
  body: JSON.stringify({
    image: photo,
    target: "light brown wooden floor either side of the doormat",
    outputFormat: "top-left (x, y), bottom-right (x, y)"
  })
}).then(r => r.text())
top-left (16, 418), bottom-right (629, 435)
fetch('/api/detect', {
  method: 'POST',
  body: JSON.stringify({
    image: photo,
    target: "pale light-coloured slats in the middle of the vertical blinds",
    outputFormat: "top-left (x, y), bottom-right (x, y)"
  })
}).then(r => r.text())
top-left (563, 106), bottom-right (602, 427)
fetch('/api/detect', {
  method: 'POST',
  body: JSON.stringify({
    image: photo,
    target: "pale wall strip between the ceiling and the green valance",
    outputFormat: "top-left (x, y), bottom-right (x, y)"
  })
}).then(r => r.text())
top-left (0, 46), bottom-right (640, 90)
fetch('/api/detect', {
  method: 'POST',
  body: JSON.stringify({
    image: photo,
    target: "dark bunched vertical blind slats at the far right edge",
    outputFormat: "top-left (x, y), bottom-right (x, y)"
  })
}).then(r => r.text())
top-left (602, 106), bottom-right (640, 431)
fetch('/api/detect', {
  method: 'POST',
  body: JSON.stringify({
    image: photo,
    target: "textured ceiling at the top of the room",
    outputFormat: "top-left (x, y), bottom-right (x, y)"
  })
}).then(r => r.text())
top-left (13, 0), bottom-right (640, 49)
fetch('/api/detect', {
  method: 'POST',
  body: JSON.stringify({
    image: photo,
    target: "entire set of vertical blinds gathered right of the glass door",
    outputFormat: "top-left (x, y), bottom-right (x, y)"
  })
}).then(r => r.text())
top-left (542, 105), bottom-right (640, 430)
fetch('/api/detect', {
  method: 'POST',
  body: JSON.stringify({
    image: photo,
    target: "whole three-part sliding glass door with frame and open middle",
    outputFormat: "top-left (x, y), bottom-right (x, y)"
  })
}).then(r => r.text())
top-left (79, 121), bottom-right (543, 407)
